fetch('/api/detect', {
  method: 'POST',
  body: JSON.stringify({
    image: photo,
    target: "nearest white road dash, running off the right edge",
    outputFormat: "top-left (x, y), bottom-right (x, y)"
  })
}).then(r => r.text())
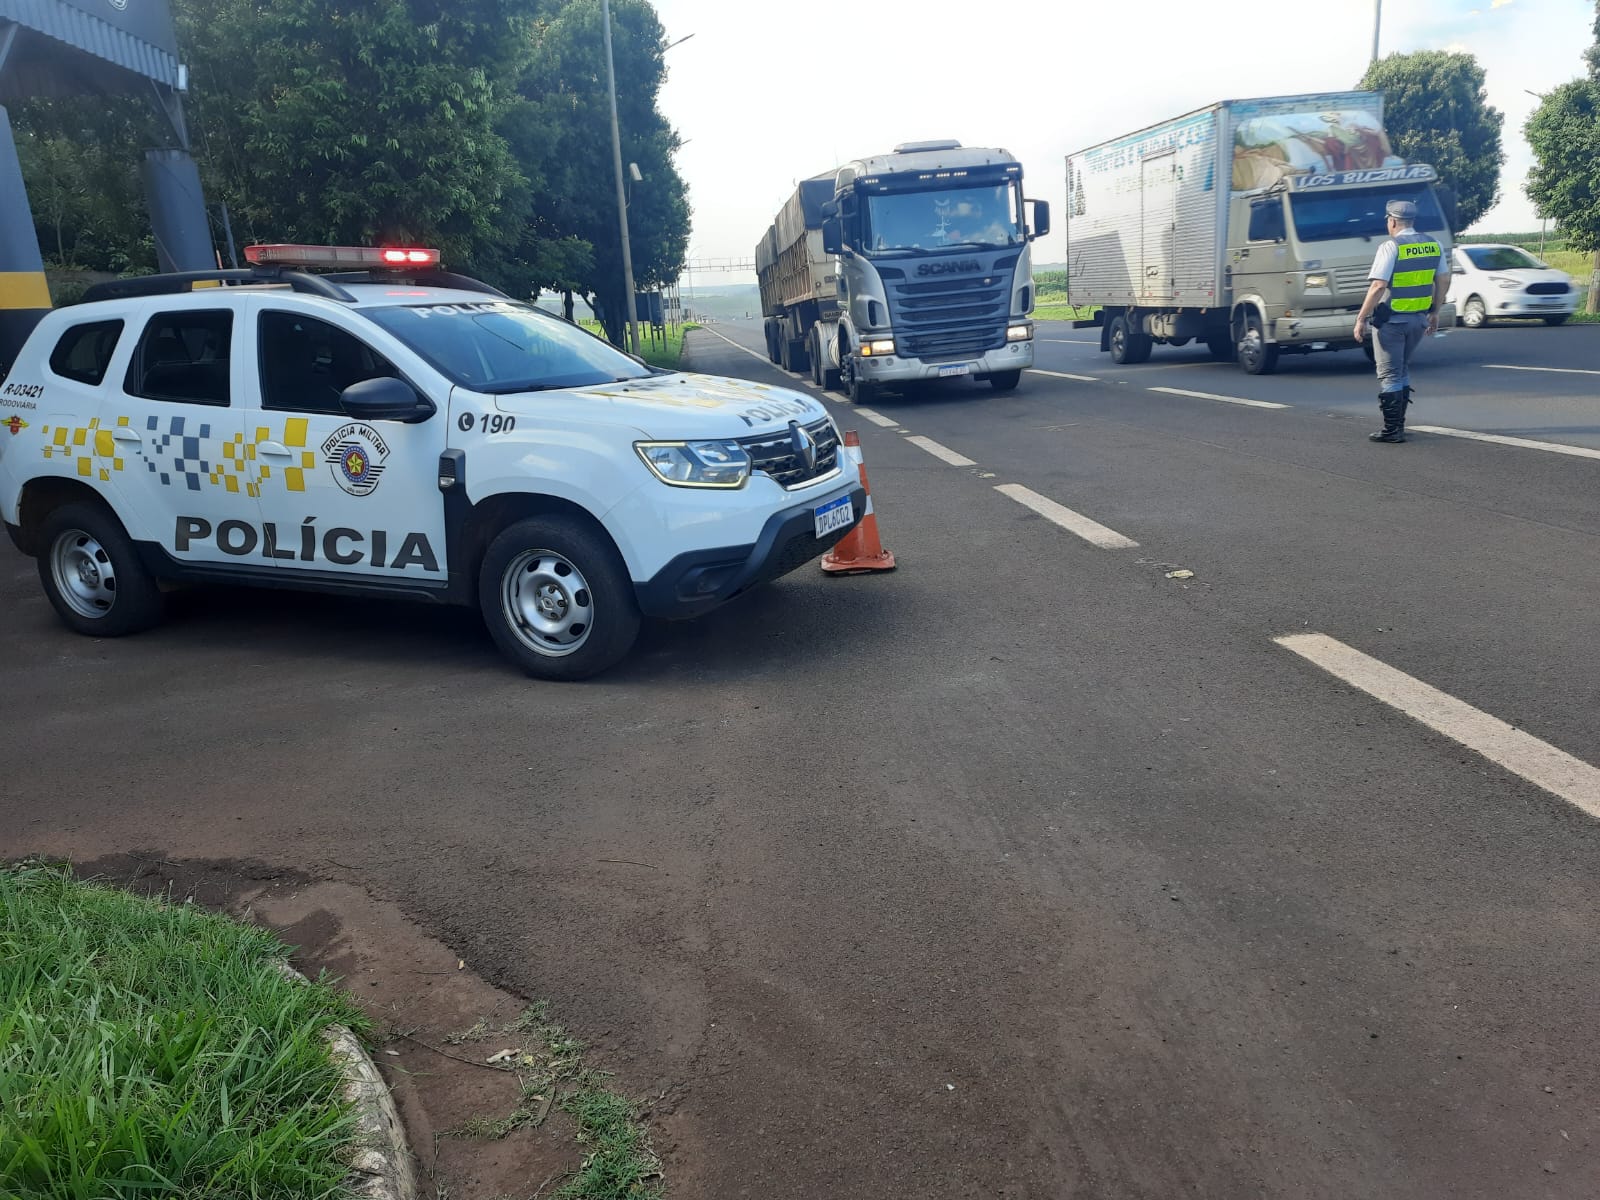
top-left (1274, 634), bottom-right (1600, 818)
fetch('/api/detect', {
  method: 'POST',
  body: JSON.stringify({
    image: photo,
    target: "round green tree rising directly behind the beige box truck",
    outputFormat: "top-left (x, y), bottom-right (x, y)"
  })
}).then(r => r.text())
top-left (1358, 50), bottom-right (1506, 229)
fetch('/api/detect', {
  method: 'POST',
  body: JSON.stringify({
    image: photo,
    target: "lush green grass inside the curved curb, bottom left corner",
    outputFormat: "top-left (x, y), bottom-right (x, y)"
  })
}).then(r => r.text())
top-left (0, 864), bottom-right (366, 1200)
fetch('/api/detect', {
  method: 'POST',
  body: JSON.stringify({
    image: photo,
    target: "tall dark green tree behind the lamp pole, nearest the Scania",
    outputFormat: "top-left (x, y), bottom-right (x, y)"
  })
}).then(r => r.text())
top-left (514, 0), bottom-right (690, 344)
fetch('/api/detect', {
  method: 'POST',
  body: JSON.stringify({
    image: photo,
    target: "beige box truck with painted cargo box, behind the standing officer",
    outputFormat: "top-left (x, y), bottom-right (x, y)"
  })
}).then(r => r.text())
top-left (1066, 91), bottom-right (1453, 374)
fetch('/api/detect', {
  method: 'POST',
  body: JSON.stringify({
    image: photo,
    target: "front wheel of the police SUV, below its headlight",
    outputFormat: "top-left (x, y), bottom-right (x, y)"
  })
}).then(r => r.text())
top-left (478, 517), bottom-right (640, 680)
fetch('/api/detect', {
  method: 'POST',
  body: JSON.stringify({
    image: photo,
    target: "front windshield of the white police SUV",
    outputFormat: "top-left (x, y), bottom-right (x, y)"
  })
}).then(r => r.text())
top-left (365, 301), bottom-right (651, 395)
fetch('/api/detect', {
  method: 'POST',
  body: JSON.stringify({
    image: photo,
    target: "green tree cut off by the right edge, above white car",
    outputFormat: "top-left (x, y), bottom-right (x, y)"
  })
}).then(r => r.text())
top-left (1525, 0), bottom-right (1600, 312)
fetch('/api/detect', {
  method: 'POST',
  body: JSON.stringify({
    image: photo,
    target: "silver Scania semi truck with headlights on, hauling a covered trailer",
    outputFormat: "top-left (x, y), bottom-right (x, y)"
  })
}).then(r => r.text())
top-left (755, 141), bottom-right (1050, 403)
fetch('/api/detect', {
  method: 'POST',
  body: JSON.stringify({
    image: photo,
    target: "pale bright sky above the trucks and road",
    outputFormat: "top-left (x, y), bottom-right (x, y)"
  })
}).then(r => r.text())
top-left (654, 0), bottom-right (1595, 286)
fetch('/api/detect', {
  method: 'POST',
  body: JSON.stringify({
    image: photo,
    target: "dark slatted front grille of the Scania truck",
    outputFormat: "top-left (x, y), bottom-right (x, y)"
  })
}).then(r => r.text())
top-left (880, 258), bottom-right (1016, 362)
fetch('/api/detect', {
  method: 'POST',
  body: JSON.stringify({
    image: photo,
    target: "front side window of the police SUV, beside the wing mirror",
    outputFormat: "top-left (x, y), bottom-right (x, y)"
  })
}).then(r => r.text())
top-left (258, 309), bottom-right (400, 416)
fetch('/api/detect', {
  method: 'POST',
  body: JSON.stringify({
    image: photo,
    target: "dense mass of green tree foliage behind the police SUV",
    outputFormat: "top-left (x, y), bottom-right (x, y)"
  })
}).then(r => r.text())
top-left (18, 0), bottom-right (690, 336)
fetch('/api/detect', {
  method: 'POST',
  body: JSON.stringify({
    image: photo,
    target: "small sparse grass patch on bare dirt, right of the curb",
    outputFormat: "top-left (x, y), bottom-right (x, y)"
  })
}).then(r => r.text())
top-left (445, 1000), bottom-right (664, 1200)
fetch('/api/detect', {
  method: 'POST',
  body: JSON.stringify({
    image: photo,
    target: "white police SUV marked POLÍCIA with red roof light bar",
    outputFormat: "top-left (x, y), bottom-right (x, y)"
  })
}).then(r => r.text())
top-left (0, 246), bottom-right (866, 680)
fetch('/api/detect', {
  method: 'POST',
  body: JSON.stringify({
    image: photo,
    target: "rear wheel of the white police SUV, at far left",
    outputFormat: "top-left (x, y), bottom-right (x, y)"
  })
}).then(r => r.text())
top-left (38, 502), bottom-right (165, 637)
